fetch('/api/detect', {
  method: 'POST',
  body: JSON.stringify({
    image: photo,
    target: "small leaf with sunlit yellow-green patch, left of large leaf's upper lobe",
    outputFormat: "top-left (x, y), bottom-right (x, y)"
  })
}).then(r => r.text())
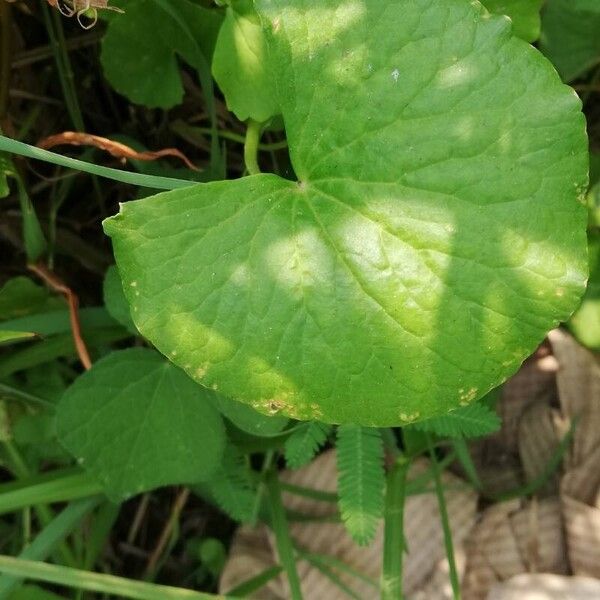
top-left (212, 0), bottom-right (279, 123)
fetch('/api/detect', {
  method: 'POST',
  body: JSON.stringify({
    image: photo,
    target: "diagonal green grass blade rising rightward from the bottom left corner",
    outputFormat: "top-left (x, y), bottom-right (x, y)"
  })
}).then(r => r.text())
top-left (0, 497), bottom-right (100, 600)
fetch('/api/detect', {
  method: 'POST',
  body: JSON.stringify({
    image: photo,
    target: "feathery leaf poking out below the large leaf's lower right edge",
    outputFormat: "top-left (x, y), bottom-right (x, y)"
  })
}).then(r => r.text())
top-left (413, 402), bottom-right (500, 438)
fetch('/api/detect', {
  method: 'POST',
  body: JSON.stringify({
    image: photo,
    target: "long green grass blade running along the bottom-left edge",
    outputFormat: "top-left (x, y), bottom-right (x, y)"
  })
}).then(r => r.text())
top-left (0, 555), bottom-right (227, 600)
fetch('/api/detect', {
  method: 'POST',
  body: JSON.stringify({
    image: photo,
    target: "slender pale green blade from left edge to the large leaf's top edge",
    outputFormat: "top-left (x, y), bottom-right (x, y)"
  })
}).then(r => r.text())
top-left (0, 135), bottom-right (192, 190)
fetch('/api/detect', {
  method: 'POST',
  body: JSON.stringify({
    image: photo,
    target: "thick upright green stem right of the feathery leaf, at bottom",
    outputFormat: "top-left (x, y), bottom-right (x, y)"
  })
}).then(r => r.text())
top-left (381, 454), bottom-right (410, 600)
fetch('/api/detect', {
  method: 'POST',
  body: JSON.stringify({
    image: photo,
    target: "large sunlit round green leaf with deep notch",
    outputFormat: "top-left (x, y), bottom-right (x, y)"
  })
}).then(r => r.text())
top-left (105, 0), bottom-right (587, 426)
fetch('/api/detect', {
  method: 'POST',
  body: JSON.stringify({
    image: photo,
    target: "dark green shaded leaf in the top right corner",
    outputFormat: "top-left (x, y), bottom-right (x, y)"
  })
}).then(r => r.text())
top-left (540, 0), bottom-right (600, 81)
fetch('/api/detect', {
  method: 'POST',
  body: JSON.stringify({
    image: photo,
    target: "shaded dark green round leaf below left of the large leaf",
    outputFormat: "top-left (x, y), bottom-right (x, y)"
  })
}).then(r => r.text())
top-left (57, 348), bottom-right (225, 501)
